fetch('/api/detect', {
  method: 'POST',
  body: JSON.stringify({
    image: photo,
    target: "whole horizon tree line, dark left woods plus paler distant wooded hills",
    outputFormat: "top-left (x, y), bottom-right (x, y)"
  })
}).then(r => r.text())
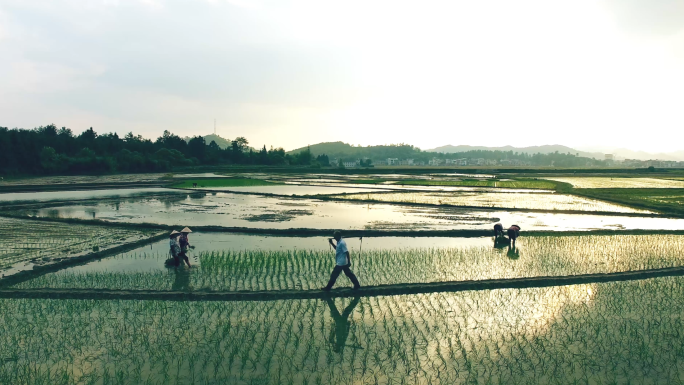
top-left (0, 124), bottom-right (605, 175)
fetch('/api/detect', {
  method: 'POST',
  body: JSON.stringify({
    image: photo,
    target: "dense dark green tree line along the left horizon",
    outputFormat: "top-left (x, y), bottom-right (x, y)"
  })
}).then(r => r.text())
top-left (0, 124), bottom-right (315, 175)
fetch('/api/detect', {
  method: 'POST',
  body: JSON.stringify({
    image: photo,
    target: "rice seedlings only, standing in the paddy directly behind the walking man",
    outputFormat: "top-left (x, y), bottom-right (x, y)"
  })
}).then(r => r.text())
top-left (16, 235), bottom-right (684, 291)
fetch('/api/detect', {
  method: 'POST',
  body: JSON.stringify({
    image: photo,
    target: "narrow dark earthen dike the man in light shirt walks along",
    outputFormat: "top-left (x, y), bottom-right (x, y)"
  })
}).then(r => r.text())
top-left (0, 266), bottom-right (684, 301)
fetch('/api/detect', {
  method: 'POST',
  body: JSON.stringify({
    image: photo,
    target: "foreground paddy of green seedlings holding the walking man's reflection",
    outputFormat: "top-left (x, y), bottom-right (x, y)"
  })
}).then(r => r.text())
top-left (0, 277), bottom-right (684, 384)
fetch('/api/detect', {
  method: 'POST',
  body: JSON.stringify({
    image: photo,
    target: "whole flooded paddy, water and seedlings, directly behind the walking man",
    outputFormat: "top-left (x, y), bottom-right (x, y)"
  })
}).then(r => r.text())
top-left (14, 234), bottom-right (684, 291)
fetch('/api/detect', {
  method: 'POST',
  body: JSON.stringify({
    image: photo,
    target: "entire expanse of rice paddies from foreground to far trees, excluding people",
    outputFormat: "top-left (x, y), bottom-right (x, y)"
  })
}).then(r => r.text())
top-left (0, 171), bottom-right (684, 385)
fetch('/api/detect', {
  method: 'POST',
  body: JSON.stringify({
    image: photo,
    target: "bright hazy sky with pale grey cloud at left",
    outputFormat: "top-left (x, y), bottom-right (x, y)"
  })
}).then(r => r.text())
top-left (0, 0), bottom-right (684, 151)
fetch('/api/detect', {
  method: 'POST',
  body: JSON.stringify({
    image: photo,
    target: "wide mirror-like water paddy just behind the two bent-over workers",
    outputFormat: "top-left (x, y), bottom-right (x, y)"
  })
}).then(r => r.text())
top-left (5, 192), bottom-right (684, 231)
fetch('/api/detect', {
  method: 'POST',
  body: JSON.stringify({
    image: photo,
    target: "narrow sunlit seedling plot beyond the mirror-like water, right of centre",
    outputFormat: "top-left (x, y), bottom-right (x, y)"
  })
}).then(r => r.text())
top-left (326, 192), bottom-right (649, 213)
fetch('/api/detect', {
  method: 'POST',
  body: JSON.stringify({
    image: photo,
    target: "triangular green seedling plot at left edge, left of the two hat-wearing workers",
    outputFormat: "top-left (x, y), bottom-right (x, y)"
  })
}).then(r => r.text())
top-left (0, 218), bottom-right (150, 270)
